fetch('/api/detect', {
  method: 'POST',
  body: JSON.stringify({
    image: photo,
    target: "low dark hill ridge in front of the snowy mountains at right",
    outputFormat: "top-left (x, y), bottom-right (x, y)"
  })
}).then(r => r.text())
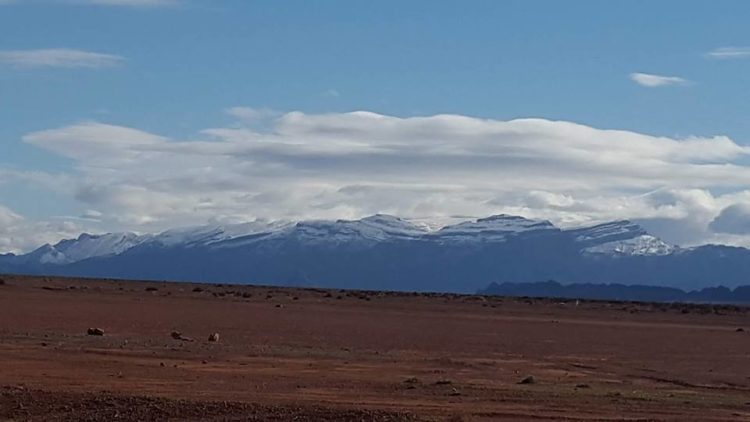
top-left (477, 281), bottom-right (750, 304)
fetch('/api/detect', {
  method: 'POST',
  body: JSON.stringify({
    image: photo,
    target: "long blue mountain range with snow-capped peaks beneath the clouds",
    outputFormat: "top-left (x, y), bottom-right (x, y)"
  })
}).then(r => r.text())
top-left (0, 214), bottom-right (750, 293)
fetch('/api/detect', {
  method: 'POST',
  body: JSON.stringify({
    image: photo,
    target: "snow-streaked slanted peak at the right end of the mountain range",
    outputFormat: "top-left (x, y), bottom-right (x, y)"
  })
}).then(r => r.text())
top-left (568, 220), bottom-right (677, 255)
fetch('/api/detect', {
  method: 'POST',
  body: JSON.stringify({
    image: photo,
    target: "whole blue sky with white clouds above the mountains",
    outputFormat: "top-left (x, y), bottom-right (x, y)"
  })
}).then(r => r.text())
top-left (0, 0), bottom-right (750, 253)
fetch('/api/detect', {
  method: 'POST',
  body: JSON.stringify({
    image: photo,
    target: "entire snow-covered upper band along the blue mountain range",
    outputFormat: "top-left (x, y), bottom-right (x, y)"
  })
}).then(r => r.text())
top-left (8, 214), bottom-right (677, 264)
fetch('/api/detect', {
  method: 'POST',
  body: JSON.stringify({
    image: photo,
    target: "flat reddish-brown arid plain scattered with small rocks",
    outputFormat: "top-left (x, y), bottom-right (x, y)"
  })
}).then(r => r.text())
top-left (0, 276), bottom-right (750, 421)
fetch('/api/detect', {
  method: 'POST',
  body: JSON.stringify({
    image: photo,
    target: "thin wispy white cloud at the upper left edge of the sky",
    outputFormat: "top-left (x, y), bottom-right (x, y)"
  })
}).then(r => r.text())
top-left (0, 48), bottom-right (124, 69)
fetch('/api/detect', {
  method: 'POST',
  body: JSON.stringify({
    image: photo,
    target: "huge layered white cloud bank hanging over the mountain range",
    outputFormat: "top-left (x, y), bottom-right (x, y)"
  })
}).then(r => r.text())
top-left (0, 109), bottom-right (750, 252)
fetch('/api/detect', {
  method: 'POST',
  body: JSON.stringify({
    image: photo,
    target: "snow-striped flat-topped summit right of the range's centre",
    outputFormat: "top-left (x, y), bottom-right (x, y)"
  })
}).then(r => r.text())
top-left (432, 214), bottom-right (560, 242)
